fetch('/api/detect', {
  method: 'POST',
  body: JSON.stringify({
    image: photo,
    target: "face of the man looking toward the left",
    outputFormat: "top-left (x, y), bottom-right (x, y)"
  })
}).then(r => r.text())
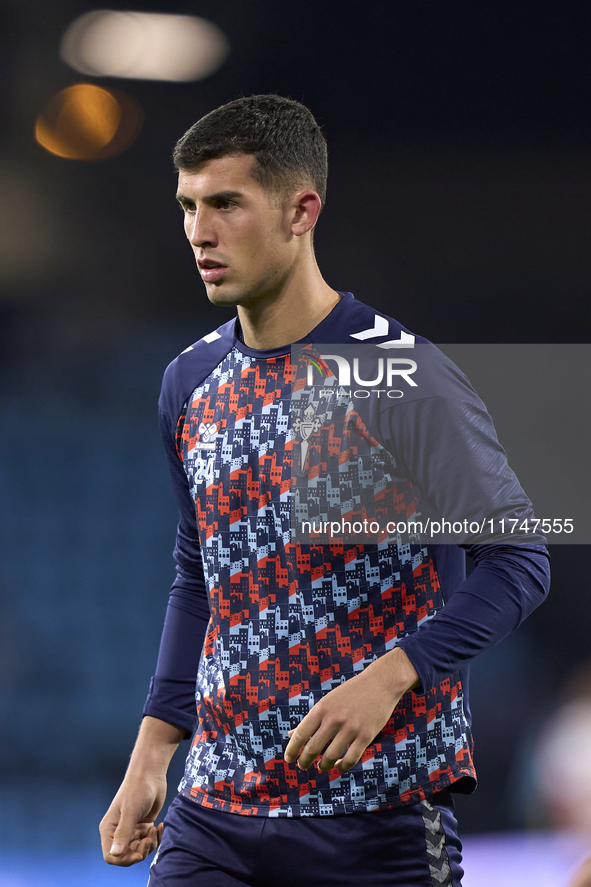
top-left (177, 154), bottom-right (296, 306)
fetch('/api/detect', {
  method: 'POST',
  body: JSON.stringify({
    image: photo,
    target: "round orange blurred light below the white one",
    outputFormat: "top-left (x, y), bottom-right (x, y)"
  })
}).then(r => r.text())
top-left (35, 83), bottom-right (143, 161)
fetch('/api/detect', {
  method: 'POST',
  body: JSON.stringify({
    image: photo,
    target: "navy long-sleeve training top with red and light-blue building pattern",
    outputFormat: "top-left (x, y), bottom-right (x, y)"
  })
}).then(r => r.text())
top-left (144, 293), bottom-right (549, 816)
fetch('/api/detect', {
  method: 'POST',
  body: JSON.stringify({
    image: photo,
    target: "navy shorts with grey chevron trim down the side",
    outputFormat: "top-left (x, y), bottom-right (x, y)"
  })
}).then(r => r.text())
top-left (147, 792), bottom-right (463, 887)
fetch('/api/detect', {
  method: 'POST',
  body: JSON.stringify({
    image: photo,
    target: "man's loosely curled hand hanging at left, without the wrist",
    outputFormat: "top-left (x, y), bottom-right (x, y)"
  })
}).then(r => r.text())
top-left (99, 775), bottom-right (166, 866)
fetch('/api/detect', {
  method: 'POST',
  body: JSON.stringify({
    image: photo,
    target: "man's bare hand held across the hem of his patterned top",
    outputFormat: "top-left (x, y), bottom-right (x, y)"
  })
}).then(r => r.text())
top-left (284, 648), bottom-right (419, 770)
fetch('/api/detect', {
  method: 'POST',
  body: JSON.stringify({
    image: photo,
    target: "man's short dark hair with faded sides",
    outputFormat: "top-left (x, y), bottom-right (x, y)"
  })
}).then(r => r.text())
top-left (172, 95), bottom-right (328, 204)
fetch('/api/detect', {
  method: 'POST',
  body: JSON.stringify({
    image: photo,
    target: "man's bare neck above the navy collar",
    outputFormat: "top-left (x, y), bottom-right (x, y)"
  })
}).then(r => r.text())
top-left (238, 257), bottom-right (340, 351)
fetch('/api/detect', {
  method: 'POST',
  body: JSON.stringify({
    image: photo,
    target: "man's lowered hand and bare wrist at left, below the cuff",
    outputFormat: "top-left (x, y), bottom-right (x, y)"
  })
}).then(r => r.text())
top-left (99, 717), bottom-right (185, 866)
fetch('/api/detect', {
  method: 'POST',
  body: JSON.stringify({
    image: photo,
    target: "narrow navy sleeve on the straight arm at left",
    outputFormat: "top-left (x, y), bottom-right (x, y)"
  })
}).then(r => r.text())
top-left (143, 408), bottom-right (209, 737)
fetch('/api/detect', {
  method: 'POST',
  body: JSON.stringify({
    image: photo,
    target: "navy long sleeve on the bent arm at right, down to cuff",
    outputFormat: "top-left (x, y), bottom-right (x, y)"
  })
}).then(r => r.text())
top-left (380, 352), bottom-right (550, 691)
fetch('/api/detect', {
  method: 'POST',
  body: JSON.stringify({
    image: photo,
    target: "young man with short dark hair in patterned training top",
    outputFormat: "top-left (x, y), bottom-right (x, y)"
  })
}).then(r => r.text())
top-left (101, 95), bottom-right (549, 887)
